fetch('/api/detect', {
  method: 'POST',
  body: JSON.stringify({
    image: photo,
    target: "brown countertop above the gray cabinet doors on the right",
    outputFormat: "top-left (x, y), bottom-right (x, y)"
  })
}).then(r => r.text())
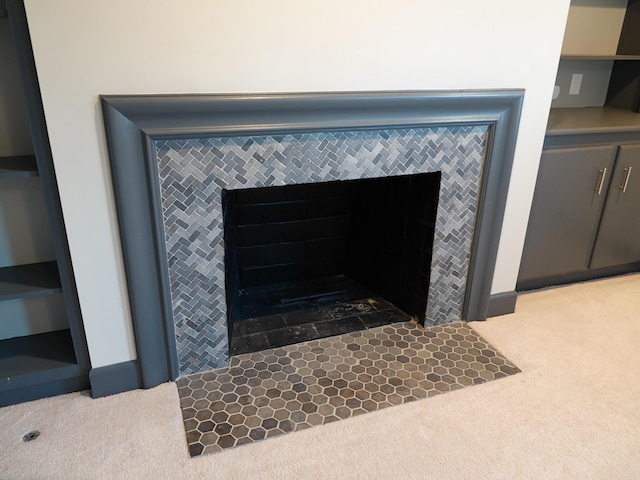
top-left (547, 107), bottom-right (640, 136)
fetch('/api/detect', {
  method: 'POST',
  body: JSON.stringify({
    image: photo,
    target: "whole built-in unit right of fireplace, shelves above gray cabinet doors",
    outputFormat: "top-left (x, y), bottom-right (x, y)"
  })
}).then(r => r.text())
top-left (516, 0), bottom-right (640, 290)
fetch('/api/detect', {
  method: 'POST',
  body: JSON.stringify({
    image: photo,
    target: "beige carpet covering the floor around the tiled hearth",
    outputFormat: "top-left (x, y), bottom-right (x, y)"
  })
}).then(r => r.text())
top-left (0, 275), bottom-right (640, 480)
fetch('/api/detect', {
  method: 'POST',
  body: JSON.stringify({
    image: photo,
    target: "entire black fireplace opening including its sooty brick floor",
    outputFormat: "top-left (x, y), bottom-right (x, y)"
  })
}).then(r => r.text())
top-left (222, 172), bottom-right (441, 355)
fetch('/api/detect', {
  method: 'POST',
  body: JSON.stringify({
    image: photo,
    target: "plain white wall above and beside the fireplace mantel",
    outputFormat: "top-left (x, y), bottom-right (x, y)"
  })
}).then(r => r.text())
top-left (25, 0), bottom-right (569, 367)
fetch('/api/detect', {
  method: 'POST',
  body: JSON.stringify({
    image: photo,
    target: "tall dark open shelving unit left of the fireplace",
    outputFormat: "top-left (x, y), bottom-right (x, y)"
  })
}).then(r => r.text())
top-left (0, 0), bottom-right (90, 406)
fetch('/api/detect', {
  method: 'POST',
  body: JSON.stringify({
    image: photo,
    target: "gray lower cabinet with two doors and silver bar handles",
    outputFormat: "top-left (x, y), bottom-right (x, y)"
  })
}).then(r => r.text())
top-left (518, 136), bottom-right (640, 289)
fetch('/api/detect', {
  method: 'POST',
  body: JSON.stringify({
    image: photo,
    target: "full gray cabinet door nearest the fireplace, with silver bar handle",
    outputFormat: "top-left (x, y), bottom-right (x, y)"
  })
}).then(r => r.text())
top-left (518, 145), bottom-right (620, 282)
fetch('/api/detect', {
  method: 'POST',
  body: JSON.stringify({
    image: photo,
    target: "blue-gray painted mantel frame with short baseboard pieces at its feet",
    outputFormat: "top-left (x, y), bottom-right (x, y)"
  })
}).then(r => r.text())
top-left (97, 90), bottom-right (524, 396)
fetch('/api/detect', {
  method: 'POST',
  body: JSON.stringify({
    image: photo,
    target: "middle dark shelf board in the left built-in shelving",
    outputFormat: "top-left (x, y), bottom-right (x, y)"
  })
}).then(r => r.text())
top-left (0, 262), bottom-right (62, 301)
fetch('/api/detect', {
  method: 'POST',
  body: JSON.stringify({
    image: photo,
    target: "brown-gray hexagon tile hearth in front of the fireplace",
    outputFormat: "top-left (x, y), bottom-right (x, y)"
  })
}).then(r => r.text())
top-left (177, 322), bottom-right (520, 456)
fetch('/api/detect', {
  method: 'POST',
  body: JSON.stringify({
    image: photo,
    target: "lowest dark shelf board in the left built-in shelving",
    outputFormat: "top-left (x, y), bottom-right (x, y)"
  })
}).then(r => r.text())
top-left (0, 330), bottom-right (79, 391)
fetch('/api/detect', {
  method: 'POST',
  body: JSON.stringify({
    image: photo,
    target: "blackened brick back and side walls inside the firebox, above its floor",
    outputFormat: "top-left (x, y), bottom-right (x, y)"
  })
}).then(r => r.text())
top-left (222, 172), bottom-right (440, 328)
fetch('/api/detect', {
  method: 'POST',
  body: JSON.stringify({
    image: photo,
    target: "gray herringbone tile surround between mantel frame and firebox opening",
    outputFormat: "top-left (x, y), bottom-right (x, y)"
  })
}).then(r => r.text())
top-left (156, 126), bottom-right (487, 374)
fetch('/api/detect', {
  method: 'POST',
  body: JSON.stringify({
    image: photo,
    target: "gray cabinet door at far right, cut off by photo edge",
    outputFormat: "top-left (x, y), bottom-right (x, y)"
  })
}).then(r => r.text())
top-left (590, 145), bottom-right (640, 268)
